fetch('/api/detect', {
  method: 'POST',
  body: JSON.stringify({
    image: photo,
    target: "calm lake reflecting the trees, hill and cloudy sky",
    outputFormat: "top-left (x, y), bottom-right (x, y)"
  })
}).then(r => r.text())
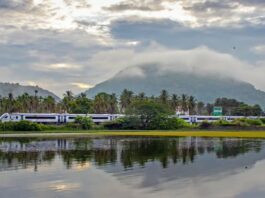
top-left (0, 137), bottom-right (265, 198)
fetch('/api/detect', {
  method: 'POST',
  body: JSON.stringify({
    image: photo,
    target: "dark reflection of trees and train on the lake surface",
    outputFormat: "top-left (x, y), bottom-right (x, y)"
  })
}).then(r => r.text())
top-left (0, 137), bottom-right (263, 171)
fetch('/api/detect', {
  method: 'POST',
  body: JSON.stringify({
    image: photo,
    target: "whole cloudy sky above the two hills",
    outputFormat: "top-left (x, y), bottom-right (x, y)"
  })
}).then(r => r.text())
top-left (0, 0), bottom-right (265, 95)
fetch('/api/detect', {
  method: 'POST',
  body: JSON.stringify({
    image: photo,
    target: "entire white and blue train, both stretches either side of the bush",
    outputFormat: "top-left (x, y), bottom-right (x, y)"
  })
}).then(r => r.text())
top-left (0, 113), bottom-right (265, 124)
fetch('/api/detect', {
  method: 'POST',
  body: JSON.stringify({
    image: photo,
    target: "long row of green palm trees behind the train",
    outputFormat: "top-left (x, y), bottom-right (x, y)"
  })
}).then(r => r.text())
top-left (0, 89), bottom-right (264, 116)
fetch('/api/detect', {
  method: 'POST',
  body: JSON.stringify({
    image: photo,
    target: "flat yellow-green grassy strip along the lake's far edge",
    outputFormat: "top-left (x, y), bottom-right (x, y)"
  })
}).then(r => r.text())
top-left (0, 130), bottom-right (265, 138)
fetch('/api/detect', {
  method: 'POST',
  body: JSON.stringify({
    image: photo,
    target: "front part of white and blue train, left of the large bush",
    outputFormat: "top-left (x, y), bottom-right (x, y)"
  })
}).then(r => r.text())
top-left (0, 113), bottom-right (123, 124)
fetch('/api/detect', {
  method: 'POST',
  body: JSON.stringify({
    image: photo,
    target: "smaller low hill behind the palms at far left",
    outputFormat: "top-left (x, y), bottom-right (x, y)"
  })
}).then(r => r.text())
top-left (0, 83), bottom-right (60, 101)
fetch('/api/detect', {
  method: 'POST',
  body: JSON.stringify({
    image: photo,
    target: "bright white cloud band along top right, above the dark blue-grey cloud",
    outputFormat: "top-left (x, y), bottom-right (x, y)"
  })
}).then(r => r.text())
top-left (103, 0), bottom-right (265, 28)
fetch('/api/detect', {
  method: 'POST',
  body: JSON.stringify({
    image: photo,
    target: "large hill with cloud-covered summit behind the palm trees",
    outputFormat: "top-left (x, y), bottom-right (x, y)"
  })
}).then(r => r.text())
top-left (86, 66), bottom-right (265, 108)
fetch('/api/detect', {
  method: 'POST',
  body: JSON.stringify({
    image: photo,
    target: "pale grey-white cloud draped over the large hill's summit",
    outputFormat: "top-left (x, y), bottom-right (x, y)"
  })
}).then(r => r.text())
top-left (87, 43), bottom-right (265, 90)
